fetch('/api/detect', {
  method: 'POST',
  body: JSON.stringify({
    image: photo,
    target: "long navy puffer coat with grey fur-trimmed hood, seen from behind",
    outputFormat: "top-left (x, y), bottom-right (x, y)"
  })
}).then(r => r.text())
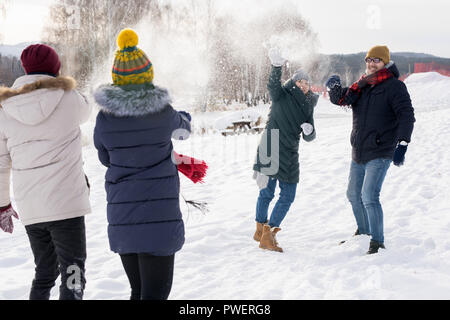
top-left (94, 85), bottom-right (190, 256)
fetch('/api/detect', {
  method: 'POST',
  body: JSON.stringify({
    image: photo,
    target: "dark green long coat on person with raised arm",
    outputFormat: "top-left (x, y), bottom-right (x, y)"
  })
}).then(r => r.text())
top-left (253, 67), bottom-right (319, 183)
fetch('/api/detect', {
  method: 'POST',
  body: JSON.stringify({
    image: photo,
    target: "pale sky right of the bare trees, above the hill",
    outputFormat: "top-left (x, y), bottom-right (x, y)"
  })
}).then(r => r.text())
top-left (298, 0), bottom-right (450, 58)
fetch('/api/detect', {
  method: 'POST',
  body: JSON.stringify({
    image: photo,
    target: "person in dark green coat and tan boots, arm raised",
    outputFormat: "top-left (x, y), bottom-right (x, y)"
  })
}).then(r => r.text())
top-left (253, 49), bottom-right (319, 252)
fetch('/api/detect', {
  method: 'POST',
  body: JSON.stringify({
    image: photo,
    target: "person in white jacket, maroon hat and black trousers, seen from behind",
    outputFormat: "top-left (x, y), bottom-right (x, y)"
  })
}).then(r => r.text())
top-left (0, 45), bottom-right (91, 299)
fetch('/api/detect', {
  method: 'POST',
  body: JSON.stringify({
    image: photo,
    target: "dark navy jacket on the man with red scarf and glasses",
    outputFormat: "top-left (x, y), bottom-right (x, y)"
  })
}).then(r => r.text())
top-left (330, 63), bottom-right (416, 163)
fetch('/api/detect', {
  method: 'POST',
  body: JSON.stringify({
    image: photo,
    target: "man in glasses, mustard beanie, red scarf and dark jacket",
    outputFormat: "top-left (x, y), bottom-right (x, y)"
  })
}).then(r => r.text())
top-left (326, 46), bottom-right (415, 254)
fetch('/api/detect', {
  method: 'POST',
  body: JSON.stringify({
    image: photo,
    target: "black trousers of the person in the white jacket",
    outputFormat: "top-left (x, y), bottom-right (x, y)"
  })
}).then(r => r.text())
top-left (25, 217), bottom-right (86, 300)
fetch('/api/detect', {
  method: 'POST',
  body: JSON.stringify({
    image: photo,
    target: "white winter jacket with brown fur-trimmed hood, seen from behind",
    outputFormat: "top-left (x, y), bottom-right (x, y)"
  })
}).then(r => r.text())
top-left (0, 75), bottom-right (91, 225)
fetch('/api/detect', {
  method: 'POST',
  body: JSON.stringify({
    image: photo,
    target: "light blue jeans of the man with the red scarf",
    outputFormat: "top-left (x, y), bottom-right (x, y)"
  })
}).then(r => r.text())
top-left (347, 158), bottom-right (392, 244)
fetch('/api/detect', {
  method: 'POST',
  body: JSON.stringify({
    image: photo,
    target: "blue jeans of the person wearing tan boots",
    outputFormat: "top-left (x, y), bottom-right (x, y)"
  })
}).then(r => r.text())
top-left (256, 178), bottom-right (297, 228)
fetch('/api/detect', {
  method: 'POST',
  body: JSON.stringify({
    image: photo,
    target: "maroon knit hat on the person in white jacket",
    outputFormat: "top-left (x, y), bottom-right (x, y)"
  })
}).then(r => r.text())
top-left (20, 44), bottom-right (61, 75)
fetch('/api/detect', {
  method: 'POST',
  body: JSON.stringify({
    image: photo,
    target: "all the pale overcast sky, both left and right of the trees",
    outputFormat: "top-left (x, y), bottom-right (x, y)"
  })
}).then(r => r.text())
top-left (0, 0), bottom-right (450, 58)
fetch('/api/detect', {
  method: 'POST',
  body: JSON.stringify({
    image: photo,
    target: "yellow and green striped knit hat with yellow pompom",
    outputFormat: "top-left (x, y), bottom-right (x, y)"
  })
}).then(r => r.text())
top-left (112, 29), bottom-right (153, 86)
